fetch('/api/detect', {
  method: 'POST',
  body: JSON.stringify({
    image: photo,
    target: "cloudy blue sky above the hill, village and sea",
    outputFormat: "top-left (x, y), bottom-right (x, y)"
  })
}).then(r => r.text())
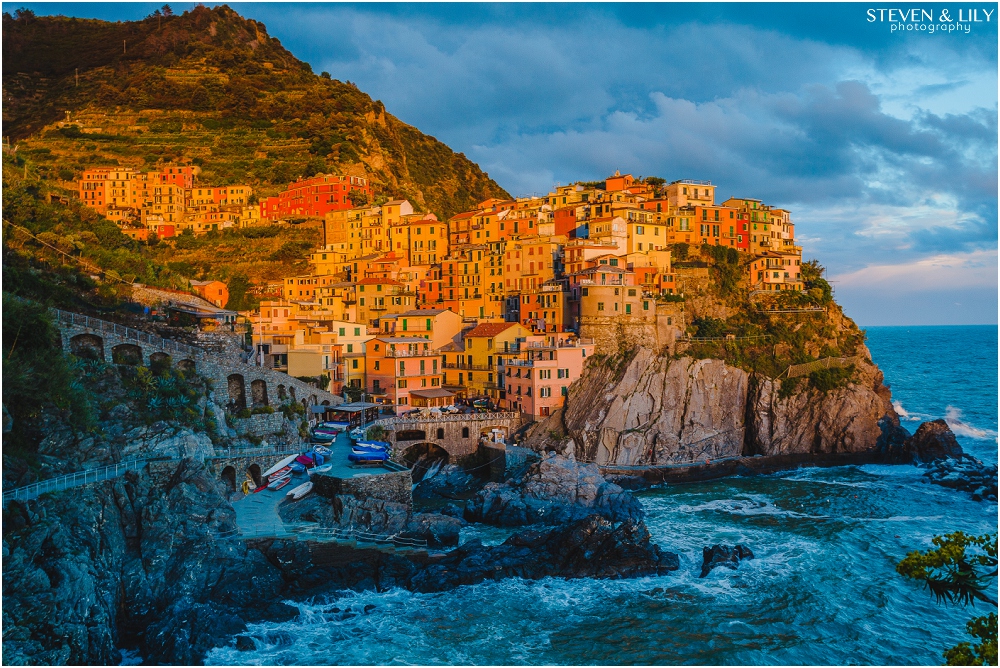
top-left (13, 2), bottom-right (1000, 326)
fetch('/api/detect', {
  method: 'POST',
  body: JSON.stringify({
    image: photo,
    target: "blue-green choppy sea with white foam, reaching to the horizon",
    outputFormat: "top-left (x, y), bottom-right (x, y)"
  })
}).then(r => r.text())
top-left (206, 326), bottom-right (997, 665)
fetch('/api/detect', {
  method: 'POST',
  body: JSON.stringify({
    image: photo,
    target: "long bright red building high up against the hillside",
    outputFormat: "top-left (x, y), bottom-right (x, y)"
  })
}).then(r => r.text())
top-left (260, 174), bottom-right (372, 220)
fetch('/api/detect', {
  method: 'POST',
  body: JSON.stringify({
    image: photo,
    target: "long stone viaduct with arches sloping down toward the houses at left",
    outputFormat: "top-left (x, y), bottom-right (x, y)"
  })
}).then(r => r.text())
top-left (53, 309), bottom-right (344, 412)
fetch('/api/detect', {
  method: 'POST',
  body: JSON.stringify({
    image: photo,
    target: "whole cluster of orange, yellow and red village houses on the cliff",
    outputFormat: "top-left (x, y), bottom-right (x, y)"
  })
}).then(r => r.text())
top-left (77, 165), bottom-right (803, 419)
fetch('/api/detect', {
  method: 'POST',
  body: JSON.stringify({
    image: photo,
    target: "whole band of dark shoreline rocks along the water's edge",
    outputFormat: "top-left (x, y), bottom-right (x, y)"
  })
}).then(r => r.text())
top-left (3, 422), bottom-right (996, 665)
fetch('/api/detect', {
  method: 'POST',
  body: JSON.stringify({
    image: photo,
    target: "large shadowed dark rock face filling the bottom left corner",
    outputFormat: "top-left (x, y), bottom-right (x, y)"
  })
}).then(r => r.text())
top-left (3, 461), bottom-right (296, 665)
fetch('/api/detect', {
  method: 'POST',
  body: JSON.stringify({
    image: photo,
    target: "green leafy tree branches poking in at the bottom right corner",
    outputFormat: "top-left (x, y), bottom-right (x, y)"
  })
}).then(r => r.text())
top-left (896, 531), bottom-right (997, 666)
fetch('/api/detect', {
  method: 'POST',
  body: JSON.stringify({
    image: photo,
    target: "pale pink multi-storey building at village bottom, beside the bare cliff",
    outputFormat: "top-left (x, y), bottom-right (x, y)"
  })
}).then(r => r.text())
top-left (503, 332), bottom-right (594, 418)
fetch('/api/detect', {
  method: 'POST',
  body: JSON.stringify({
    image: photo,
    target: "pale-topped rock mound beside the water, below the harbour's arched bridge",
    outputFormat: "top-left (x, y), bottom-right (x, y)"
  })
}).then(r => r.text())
top-left (465, 453), bottom-right (644, 526)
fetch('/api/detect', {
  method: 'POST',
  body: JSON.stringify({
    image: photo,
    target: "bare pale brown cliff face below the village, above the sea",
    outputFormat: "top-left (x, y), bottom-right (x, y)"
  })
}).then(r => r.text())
top-left (528, 348), bottom-right (898, 465)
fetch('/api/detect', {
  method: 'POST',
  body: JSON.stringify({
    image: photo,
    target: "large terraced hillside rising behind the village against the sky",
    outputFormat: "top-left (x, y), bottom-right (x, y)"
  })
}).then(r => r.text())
top-left (3, 6), bottom-right (507, 218)
